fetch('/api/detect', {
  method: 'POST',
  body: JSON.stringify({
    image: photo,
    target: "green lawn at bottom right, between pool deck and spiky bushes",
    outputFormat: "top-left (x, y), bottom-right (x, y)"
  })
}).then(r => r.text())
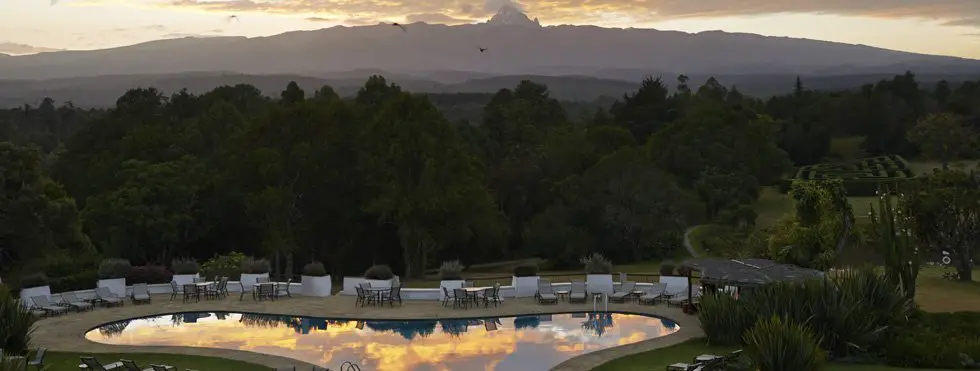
top-left (592, 339), bottom-right (948, 371)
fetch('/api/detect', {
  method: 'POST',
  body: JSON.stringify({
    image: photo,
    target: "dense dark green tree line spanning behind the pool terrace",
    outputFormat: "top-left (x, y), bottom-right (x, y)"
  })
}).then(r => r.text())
top-left (0, 74), bottom-right (980, 282)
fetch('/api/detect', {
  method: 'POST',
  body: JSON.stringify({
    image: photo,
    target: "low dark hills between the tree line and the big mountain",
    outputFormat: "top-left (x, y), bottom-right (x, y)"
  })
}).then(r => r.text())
top-left (0, 70), bottom-right (980, 107)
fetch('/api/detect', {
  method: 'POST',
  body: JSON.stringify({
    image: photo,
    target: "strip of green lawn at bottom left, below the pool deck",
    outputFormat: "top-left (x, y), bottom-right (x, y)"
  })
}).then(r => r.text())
top-left (44, 352), bottom-right (269, 371)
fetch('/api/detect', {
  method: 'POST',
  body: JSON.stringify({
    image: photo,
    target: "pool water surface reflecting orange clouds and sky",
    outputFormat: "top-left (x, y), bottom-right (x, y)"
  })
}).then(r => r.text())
top-left (85, 312), bottom-right (679, 371)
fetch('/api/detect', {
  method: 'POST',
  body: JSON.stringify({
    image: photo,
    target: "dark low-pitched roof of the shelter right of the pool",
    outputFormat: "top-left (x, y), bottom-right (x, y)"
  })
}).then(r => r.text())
top-left (681, 258), bottom-right (823, 287)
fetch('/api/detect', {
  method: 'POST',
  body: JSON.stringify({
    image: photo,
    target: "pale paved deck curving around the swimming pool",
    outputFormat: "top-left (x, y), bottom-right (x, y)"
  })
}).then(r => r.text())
top-left (33, 293), bottom-right (704, 371)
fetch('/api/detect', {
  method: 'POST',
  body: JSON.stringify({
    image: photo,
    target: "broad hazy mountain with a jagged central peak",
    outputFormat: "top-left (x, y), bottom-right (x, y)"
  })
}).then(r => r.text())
top-left (0, 7), bottom-right (980, 81)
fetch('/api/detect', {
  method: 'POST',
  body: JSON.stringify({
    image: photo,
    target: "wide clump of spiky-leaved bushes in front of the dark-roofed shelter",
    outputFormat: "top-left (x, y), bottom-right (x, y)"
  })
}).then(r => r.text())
top-left (699, 268), bottom-right (912, 357)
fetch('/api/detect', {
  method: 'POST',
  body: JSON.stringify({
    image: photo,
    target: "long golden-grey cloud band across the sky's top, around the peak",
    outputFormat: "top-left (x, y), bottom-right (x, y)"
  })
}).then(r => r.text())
top-left (161, 0), bottom-right (980, 27)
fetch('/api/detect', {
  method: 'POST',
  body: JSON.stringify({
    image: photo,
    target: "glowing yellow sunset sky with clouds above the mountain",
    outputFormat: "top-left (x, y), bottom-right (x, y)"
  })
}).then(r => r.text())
top-left (0, 0), bottom-right (980, 59)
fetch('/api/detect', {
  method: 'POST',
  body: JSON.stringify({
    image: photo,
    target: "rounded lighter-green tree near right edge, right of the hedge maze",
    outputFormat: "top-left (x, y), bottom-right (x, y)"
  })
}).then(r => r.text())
top-left (908, 113), bottom-right (976, 169)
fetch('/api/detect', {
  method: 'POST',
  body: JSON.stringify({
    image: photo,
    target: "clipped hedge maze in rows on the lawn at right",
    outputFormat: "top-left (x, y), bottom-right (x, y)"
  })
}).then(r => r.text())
top-left (795, 155), bottom-right (915, 196)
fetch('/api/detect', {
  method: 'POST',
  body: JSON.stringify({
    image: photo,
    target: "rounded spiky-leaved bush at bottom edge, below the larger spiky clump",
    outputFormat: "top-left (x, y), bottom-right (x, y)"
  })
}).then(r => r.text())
top-left (744, 316), bottom-right (824, 371)
